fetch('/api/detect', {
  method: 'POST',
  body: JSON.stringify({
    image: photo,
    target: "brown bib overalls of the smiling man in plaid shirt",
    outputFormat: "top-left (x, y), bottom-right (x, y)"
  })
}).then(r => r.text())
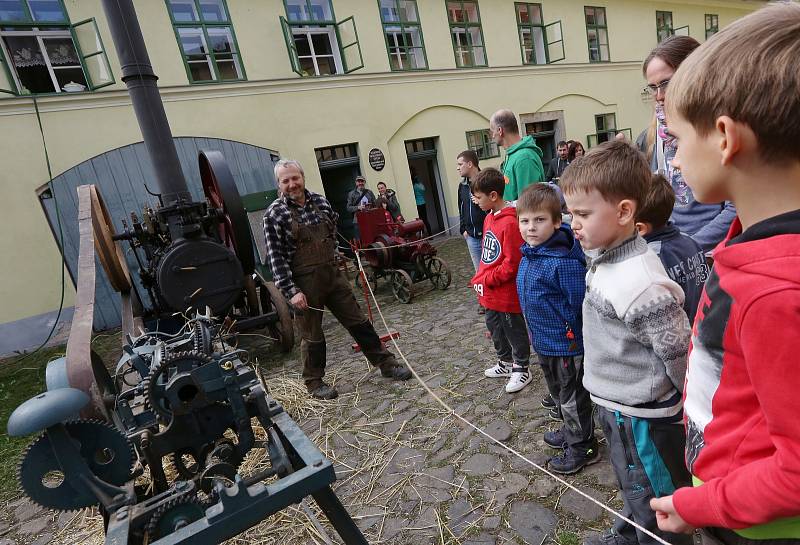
top-left (291, 203), bottom-right (396, 391)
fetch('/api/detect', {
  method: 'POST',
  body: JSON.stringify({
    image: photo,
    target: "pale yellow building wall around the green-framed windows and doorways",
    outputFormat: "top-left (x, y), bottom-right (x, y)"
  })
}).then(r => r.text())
top-left (0, 0), bottom-right (758, 324)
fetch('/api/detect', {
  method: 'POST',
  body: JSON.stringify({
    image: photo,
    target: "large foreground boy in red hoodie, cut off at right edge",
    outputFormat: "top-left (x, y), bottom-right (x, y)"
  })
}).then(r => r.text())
top-left (650, 3), bottom-right (800, 545)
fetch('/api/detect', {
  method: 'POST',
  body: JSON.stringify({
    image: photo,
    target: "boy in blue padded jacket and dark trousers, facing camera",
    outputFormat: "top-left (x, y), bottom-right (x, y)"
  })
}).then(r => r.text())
top-left (517, 184), bottom-right (600, 475)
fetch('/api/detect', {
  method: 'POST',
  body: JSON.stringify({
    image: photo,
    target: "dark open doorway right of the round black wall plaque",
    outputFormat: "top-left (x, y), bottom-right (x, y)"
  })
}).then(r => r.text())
top-left (405, 138), bottom-right (449, 235)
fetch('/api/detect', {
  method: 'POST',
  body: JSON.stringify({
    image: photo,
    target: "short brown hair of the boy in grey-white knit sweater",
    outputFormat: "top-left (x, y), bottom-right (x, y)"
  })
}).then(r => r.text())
top-left (559, 140), bottom-right (651, 207)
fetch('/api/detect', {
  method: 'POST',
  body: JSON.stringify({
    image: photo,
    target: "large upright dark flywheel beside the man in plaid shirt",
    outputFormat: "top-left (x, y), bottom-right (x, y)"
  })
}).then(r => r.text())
top-left (199, 151), bottom-right (256, 274)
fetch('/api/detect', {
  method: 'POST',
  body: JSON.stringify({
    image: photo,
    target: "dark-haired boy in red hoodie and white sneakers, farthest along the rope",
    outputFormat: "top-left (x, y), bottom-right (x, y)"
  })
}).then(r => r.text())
top-left (470, 168), bottom-right (531, 393)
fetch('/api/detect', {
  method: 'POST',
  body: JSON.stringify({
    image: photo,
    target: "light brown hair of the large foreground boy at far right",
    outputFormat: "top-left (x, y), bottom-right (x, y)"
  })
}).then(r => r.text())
top-left (667, 3), bottom-right (800, 161)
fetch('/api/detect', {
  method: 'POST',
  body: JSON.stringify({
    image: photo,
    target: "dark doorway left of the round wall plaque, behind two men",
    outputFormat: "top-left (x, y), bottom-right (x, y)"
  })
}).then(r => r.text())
top-left (315, 144), bottom-right (360, 240)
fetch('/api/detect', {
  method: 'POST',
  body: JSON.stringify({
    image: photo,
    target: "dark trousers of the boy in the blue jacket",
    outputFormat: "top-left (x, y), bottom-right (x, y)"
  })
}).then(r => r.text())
top-left (539, 354), bottom-right (595, 452)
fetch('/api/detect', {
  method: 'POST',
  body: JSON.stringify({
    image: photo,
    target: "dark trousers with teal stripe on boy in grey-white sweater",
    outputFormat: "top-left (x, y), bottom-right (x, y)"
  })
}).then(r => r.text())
top-left (597, 406), bottom-right (692, 545)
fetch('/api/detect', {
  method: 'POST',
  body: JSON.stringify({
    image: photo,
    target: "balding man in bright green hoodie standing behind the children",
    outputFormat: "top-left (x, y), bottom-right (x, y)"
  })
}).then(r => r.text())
top-left (489, 110), bottom-right (545, 203)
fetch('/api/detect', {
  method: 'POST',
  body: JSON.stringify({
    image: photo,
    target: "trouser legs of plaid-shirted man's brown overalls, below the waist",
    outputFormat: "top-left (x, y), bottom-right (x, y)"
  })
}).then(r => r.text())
top-left (293, 265), bottom-right (395, 390)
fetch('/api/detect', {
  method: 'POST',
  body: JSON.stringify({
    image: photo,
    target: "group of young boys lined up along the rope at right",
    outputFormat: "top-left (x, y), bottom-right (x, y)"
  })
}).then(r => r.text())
top-left (462, 3), bottom-right (800, 545)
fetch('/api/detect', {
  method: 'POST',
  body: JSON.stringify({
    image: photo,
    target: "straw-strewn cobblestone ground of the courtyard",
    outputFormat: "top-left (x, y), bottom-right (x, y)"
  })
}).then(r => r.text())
top-left (0, 239), bottom-right (621, 545)
